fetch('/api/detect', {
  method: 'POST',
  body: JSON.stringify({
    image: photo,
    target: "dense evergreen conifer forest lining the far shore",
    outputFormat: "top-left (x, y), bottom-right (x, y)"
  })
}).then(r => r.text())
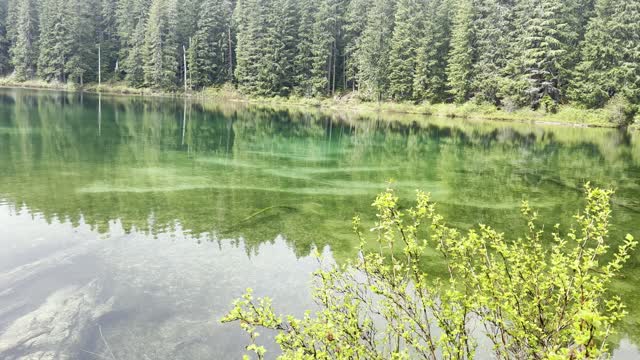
top-left (0, 0), bottom-right (640, 109)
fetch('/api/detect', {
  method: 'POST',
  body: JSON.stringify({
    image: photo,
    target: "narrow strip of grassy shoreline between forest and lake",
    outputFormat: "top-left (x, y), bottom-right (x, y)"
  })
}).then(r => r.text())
top-left (0, 78), bottom-right (639, 129)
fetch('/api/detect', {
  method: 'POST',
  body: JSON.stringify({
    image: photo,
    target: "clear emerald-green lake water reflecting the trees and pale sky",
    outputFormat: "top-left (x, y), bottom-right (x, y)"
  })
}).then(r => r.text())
top-left (0, 89), bottom-right (640, 359)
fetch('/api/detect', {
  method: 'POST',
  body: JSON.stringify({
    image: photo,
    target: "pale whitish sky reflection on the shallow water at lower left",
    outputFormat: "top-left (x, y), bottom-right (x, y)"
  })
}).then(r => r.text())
top-left (0, 205), bottom-right (320, 360)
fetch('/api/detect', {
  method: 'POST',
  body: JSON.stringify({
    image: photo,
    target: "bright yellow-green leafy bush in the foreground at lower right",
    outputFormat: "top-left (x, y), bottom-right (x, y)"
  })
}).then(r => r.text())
top-left (222, 185), bottom-right (637, 359)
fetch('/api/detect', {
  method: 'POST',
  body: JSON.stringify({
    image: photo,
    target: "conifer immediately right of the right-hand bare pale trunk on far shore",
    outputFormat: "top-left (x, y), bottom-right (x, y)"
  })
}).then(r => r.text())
top-left (190, 0), bottom-right (231, 88)
